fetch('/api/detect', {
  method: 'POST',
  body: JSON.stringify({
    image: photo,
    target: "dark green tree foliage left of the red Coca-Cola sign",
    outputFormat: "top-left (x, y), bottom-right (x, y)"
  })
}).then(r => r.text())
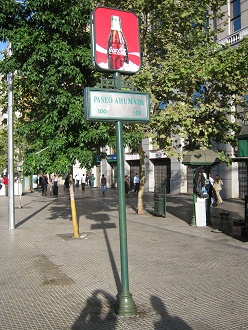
top-left (0, 0), bottom-right (119, 174)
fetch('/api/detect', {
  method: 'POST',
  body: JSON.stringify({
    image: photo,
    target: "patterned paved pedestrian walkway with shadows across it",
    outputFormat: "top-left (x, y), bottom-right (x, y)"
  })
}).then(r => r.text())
top-left (0, 187), bottom-right (248, 330)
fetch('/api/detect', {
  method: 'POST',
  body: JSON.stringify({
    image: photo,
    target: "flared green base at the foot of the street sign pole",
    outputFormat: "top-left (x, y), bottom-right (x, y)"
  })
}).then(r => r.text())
top-left (115, 293), bottom-right (137, 316)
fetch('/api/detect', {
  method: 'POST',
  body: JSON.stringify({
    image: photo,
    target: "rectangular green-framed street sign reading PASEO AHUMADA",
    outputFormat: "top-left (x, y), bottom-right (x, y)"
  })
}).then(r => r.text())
top-left (84, 87), bottom-right (150, 123)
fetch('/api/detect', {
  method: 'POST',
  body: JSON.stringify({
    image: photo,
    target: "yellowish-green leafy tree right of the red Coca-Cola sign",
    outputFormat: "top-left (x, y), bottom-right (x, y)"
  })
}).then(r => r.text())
top-left (98, 0), bottom-right (248, 211)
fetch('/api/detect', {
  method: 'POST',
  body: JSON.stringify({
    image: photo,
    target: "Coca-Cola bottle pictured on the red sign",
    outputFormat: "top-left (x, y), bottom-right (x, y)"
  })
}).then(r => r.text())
top-left (107, 16), bottom-right (129, 70)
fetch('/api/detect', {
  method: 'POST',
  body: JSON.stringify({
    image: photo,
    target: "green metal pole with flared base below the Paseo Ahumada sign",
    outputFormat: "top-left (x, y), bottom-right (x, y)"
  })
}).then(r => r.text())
top-left (115, 121), bottom-right (137, 316)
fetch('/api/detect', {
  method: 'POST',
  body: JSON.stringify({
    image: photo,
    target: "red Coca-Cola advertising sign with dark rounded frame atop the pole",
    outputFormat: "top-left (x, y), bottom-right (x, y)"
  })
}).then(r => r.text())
top-left (91, 7), bottom-right (141, 75)
